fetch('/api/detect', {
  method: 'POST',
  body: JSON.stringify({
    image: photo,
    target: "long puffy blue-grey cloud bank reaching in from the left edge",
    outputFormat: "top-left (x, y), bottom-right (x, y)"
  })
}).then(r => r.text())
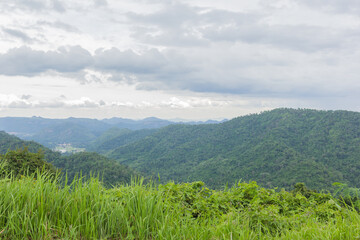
top-left (0, 46), bottom-right (168, 76)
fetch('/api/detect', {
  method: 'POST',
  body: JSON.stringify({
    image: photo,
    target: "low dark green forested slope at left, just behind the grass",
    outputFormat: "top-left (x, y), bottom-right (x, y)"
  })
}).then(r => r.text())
top-left (0, 132), bottom-right (139, 186)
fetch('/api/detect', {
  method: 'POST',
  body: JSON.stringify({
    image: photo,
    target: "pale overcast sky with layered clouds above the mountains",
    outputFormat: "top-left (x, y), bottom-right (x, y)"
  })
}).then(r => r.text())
top-left (0, 0), bottom-right (360, 120)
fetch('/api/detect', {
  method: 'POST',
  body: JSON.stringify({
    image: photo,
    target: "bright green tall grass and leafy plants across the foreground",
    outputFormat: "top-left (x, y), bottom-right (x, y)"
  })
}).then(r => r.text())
top-left (0, 170), bottom-right (360, 240)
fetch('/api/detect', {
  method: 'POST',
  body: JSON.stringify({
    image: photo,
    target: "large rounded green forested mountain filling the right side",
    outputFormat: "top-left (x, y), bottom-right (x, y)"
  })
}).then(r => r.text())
top-left (108, 109), bottom-right (360, 189)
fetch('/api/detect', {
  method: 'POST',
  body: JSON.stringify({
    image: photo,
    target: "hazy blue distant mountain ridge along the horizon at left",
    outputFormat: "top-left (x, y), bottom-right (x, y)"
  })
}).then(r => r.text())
top-left (0, 117), bottom-right (225, 148)
